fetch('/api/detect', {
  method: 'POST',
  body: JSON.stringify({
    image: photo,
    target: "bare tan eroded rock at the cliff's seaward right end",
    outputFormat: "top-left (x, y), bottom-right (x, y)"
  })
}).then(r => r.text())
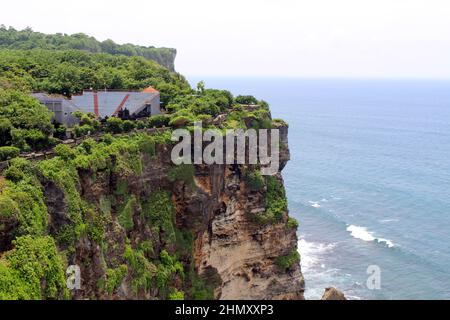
top-left (191, 168), bottom-right (304, 299)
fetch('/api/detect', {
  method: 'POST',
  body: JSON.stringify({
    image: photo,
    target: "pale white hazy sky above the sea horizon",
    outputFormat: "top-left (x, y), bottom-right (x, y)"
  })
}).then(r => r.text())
top-left (0, 0), bottom-right (450, 78)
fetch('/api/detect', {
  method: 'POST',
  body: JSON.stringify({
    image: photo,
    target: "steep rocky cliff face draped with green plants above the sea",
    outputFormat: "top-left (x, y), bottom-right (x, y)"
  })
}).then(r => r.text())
top-left (0, 125), bottom-right (304, 299)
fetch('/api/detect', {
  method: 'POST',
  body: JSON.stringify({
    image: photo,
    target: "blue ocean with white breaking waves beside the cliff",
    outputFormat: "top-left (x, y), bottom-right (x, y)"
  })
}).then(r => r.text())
top-left (188, 77), bottom-right (450, 299)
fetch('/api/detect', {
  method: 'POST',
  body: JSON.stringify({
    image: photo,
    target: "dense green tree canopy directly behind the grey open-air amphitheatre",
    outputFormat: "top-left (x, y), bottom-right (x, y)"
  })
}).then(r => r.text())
top-left (0, 48), bottom-right (188, 99)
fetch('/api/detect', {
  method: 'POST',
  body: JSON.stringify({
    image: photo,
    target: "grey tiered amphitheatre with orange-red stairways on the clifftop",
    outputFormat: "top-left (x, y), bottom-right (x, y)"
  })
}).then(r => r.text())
top-left (32, 87), bottom-right (161, 127)
